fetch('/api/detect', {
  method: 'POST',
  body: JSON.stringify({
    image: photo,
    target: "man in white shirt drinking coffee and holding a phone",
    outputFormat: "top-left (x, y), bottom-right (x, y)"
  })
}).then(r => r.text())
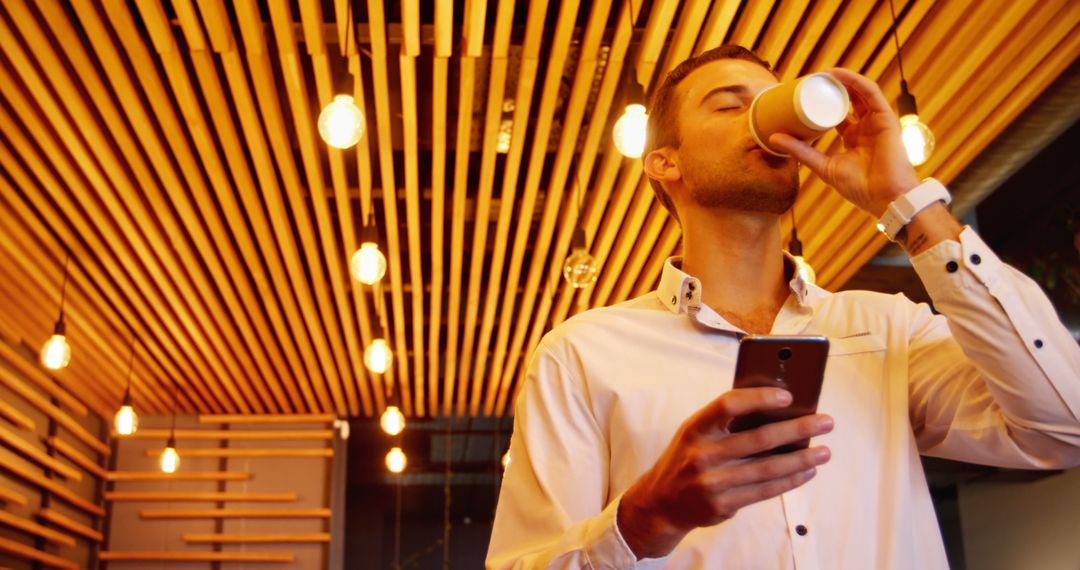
top-left (488, 46), bottom-right (1080, 570)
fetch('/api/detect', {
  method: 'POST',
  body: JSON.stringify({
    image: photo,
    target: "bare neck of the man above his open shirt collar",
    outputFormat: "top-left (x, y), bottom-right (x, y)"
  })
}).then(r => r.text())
top-left (680, 208), bottom-right (788, 334)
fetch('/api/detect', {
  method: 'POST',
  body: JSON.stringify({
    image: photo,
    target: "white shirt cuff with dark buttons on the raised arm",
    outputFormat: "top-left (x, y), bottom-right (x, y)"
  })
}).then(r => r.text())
top-left (912, 226), bottom-right (1002, 299)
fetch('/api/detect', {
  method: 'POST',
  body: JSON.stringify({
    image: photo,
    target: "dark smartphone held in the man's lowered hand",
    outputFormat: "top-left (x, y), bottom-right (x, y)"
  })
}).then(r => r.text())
top-left (728, 335), bottom-right (828, 457)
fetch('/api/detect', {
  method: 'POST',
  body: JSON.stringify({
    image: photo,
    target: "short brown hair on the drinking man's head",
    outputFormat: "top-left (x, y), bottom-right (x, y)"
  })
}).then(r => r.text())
top-left (643, 45), bottom-right (777, 221)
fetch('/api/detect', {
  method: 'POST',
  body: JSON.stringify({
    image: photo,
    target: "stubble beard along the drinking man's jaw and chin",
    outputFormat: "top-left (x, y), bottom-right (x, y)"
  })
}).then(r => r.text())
top-left (683, 150), bottom-right (799, 215)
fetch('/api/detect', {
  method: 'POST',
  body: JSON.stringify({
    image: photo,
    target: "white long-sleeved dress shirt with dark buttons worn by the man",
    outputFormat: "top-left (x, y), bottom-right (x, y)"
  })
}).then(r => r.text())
top-left (487, 228), bottom-right (1080, 570)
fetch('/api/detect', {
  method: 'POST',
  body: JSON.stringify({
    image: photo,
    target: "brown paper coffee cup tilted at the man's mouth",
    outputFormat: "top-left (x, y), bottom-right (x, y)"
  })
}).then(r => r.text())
top-left (750, 73), bottom-right (851, 157)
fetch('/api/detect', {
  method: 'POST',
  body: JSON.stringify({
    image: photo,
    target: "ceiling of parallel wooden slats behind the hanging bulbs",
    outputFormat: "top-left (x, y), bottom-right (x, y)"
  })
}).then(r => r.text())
top-left (0, 0), bottom-right (1080, 417)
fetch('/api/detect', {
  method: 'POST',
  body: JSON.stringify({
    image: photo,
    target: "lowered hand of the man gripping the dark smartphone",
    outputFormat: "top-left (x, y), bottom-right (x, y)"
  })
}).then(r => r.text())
top-left (617, 388), bottom-right (833, 559)
